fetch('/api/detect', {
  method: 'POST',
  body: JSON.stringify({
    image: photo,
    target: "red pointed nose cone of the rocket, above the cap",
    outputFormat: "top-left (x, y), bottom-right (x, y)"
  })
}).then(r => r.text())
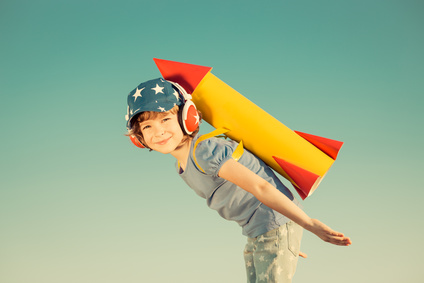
top-left (153, 58), bottom-right (212, 93)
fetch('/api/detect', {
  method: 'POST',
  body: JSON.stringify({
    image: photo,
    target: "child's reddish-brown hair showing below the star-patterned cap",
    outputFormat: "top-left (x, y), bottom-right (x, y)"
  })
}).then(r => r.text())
top-left (128, 105), bottom-right (202, 150)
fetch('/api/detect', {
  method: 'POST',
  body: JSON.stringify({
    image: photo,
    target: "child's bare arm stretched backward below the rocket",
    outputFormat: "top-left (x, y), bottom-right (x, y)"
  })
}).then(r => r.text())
top-left (218, 159), bottom-right (352, 246)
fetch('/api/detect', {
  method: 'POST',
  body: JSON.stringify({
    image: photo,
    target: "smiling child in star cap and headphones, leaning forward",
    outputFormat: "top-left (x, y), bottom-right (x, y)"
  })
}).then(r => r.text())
top-left (126, 78), bottom-right (351, 282)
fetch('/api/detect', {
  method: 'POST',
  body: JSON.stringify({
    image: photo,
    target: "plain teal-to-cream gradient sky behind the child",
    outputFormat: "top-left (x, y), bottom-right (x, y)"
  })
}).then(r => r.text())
top-left (0, 0), bottom-right (424, 283)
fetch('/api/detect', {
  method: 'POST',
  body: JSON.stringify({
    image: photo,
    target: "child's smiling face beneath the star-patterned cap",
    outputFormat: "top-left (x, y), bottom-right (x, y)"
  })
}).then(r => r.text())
top-left (140, 112), bottom-right (184, 154)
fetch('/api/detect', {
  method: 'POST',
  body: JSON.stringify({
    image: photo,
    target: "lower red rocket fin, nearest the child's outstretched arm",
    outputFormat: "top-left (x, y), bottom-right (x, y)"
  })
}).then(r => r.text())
top-left (272, 156), bottom-right (319, 199)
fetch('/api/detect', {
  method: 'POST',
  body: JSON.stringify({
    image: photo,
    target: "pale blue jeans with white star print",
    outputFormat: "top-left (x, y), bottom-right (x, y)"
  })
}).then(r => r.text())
top-left (244, 221), bottom-right (303, 283)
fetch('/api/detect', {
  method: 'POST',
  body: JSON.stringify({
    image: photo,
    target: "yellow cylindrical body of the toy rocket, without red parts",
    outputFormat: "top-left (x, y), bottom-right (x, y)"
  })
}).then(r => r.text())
top-left (192, 72), bottom-right (334, 187)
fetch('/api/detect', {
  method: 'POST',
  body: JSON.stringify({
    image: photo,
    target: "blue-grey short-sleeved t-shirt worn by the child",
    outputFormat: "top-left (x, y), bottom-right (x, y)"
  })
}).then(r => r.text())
top-left (177, 136), bottom-right (300, 238)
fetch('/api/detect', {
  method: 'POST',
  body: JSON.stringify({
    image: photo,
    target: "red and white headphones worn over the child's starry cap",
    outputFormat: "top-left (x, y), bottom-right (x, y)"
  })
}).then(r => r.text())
top-left (129, 81), bottom-right (199, 148)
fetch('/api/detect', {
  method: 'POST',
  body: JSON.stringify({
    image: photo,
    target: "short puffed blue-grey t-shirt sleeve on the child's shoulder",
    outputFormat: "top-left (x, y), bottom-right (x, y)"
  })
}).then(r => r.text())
top-left (194, 138), bottom-right (237, 176)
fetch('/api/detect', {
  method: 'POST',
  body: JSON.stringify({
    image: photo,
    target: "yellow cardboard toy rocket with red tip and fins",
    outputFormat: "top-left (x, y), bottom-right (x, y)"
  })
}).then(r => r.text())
top-left (153, 59), bottom-right (343, 199)
